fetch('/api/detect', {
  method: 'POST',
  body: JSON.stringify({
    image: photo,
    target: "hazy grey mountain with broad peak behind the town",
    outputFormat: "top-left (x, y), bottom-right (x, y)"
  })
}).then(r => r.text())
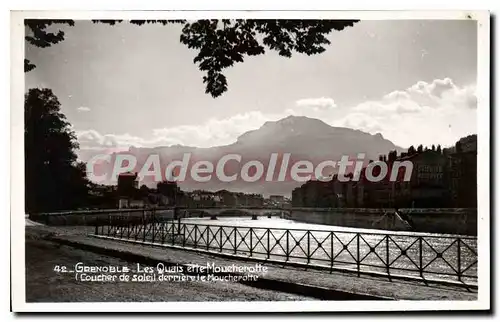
top-left (81, 116), bottom-right (403, 195)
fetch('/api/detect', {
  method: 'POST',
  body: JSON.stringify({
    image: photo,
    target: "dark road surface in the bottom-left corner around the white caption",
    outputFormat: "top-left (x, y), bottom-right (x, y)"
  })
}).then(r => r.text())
top-left (25, 239), bottom-right (317, 303)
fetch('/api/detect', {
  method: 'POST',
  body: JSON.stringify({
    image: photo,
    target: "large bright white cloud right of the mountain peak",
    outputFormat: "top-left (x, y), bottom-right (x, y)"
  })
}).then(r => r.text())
top-left (338, 78), bottom-right (477, 147)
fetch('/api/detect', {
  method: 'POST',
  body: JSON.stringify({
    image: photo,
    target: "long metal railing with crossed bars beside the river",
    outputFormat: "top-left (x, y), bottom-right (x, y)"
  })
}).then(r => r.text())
top-left (95, 220), bottom-right (477, 286)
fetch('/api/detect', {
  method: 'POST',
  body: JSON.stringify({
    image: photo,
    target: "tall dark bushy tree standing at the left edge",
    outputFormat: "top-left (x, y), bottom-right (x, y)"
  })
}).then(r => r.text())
top-left (24, 89), bottom-right (89, 213)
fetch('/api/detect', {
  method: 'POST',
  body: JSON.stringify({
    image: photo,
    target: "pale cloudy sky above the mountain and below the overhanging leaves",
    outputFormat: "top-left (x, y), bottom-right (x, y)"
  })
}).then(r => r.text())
top-left (25, 20), bottom-right (477, 155)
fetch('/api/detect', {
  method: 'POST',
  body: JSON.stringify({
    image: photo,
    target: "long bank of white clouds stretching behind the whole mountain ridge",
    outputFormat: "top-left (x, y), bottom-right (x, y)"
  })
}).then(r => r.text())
top-left (77, 78), bottom-right (477, 149)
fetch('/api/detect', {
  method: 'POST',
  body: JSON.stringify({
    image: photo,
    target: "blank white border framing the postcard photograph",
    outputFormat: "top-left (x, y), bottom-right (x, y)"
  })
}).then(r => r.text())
top-left (10, 11), bottom-right (491, 312)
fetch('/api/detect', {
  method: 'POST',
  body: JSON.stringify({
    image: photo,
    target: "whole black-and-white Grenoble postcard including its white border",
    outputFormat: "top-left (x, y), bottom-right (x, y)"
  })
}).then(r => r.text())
top-left (11, 11), bottom-right (490, 312)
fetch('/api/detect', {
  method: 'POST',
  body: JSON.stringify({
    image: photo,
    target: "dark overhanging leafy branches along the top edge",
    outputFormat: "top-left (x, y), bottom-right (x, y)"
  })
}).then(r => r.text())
top-left (25, 19), bottom-right (358, 98)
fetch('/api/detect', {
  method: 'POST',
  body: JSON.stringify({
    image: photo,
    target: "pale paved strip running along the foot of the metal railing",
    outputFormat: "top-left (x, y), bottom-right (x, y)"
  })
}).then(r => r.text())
top-left (30, 227), bottom-right (477, 300)
